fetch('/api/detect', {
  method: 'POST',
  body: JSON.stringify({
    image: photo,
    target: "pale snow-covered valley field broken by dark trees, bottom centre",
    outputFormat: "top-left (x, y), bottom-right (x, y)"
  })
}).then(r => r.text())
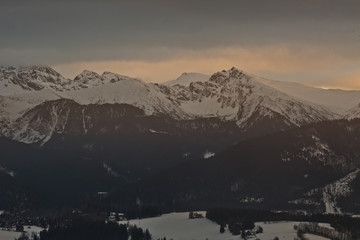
top-left (120, 212), bottom-right (325, 240)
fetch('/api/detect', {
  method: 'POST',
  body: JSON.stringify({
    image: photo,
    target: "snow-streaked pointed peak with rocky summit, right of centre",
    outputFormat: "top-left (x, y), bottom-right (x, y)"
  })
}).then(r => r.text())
top-left (165, 68), bottom-right (337, 128)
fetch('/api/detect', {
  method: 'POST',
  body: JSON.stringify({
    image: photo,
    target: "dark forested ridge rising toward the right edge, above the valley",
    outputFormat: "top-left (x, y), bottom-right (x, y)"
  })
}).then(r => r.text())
top-left (109, 119), bottom-right (360, 213)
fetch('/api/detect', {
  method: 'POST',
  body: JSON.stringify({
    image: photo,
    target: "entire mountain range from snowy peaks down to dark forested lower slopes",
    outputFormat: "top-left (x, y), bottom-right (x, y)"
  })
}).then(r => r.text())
top-left (0, 66), bottom-right (360, 212)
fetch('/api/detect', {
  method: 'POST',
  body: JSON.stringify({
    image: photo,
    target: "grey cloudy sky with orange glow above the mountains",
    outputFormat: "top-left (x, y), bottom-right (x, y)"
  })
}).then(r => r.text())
top-left (0, 0), bottom-right (360, 89)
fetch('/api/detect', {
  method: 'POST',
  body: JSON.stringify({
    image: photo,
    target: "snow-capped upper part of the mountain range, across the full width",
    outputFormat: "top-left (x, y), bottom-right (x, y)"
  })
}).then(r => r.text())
top-left (0, 66), bottom-right (360, 143)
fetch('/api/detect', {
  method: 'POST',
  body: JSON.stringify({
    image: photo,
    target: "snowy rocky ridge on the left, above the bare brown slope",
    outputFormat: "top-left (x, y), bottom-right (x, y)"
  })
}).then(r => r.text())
top-left (0, 66), bottom-right (187, 125)
